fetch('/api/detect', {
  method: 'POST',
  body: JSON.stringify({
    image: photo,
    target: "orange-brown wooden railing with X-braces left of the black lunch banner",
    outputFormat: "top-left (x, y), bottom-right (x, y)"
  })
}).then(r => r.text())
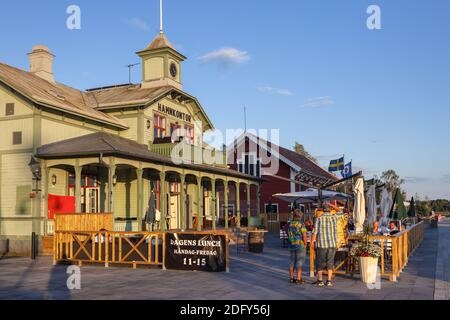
top-left (53, 231), bottom-right (166, 269)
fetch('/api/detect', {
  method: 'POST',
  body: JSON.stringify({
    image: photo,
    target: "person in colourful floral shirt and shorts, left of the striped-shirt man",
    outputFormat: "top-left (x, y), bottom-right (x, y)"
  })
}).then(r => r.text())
top-left (286, 210), bottom-right (308, 284)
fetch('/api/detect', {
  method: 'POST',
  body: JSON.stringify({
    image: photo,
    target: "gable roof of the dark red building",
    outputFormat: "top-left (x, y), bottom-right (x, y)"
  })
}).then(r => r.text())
top-left (229, 132), bottom-right (338, 181)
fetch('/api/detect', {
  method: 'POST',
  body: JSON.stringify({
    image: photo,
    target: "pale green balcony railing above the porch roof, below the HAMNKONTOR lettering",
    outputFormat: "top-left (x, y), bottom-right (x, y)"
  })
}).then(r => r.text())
top-left (149, 142), bottom-right (227, 168)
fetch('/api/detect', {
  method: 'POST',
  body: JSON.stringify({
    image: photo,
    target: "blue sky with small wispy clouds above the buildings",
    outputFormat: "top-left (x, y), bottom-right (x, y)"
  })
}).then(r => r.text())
top-left (0, 0), bottom-right (450, 199)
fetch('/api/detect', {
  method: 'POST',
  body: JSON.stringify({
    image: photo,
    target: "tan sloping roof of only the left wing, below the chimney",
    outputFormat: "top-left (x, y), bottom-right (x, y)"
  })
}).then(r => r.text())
top-left (0, 63), bottom-right (128, 129)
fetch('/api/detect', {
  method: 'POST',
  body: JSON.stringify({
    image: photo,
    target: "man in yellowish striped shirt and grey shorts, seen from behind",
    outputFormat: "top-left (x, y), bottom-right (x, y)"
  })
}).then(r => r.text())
top-left (311, 210), bottom-right (338, 287)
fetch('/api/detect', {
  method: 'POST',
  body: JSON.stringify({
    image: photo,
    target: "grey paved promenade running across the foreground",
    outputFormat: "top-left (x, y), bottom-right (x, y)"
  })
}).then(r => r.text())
top-left (0, 220), bottom-right (450, 300)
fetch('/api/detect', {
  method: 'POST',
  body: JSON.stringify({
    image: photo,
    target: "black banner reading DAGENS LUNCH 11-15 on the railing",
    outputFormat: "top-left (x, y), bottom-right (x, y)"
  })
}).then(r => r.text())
top-left (166, 233), bottom-right (228, 272)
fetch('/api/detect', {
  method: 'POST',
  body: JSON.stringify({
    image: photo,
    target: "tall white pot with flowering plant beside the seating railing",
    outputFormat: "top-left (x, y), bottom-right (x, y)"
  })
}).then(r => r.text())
top-left (351, 226), bottom-right (383, 284)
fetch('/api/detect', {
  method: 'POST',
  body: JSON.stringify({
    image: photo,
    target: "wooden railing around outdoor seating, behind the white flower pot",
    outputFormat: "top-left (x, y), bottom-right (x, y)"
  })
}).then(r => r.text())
top-left (310, 222), bottom-right (424, 281)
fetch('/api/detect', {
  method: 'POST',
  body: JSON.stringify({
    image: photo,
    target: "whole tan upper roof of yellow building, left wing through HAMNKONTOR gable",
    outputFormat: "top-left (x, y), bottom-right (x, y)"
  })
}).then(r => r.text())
top-left (0, 63), bottom-right (214, 130)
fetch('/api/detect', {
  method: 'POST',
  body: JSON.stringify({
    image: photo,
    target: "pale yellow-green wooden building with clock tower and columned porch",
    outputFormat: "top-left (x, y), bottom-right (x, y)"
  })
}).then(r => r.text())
top-left (0, 32), bottom-right (260, 252)
